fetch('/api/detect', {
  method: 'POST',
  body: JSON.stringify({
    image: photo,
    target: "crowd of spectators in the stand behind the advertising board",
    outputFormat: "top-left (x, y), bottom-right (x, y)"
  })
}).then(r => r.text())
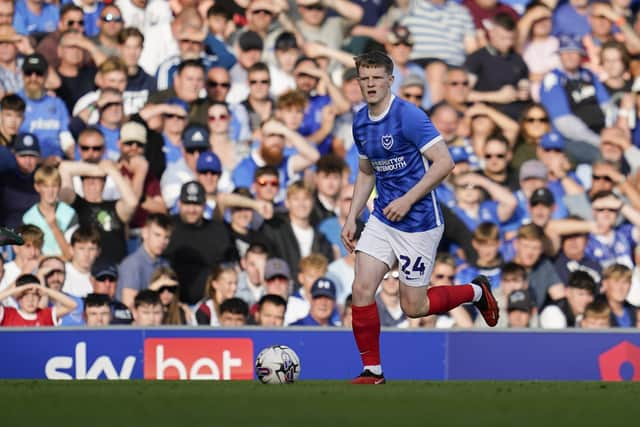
top-left (0, 0), bottom-right (640, 328)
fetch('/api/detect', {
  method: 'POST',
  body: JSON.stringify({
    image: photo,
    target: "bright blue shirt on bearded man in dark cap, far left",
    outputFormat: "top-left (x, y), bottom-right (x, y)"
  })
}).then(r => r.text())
top-left (18, 91), bottom-right (69, 158)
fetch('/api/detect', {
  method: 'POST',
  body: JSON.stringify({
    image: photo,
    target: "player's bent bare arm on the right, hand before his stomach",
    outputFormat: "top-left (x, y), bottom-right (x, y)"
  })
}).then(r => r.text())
top-left (382, 140), bottom-right (454, 221)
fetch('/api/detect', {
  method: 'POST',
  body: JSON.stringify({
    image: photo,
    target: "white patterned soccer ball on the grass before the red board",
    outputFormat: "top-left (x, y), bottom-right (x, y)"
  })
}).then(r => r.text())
top-left (256, 345), bottom-right (300, 384)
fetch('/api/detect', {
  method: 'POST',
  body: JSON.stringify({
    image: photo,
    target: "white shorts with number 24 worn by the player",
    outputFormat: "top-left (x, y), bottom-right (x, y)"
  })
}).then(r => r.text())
top-left (356, 215), bottom-right (444, 287)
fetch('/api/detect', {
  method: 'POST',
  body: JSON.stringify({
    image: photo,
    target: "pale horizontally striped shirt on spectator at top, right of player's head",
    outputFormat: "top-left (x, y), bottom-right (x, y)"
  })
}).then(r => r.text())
top-left (402, 0), bottom-right (475, 65)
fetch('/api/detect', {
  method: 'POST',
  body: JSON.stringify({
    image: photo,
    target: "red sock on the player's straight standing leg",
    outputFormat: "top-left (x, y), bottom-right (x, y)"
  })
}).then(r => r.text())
top-left (351, 302), bottom-right (380, 366)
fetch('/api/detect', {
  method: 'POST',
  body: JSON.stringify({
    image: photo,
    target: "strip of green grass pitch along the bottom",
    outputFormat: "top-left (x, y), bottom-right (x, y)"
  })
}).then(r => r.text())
top-left (0, 381), bottom-right (640, 427)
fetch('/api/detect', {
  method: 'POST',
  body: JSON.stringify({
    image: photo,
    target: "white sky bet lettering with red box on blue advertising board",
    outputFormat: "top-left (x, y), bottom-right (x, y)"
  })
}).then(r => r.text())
top-left (44, 338), bottom-right (253, 380)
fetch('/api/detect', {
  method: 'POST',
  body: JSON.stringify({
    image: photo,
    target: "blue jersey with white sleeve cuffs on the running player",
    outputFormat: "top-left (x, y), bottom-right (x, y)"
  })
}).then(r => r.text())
top-left (353, 97), bottom-right (442, 232)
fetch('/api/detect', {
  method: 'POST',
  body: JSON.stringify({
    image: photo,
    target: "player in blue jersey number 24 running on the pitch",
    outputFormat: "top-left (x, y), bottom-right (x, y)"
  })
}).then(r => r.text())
top-left (342, 51), bottom-right (498, 384)
